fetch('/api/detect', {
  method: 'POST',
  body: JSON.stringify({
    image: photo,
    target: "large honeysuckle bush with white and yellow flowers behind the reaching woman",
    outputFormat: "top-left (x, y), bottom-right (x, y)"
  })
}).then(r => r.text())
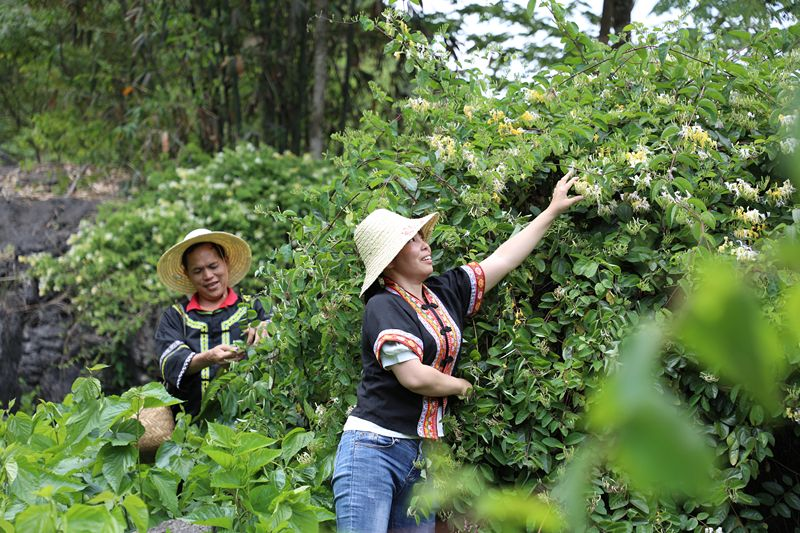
top-left (247, 3), bottom-right (800, 531)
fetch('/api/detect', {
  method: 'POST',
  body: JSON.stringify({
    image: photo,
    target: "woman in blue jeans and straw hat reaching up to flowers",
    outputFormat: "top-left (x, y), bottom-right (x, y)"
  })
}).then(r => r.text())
top-left (333, 171), bottom-right (583, 533)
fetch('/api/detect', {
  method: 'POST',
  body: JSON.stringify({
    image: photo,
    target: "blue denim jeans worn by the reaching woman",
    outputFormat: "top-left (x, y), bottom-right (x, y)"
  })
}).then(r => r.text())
top-left (333, 431), bottom-right (435, 533)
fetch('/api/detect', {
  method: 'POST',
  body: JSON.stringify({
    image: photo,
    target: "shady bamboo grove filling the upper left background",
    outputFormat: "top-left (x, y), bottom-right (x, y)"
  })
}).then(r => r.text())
top-left (0, 0), bottom-right (407, 164)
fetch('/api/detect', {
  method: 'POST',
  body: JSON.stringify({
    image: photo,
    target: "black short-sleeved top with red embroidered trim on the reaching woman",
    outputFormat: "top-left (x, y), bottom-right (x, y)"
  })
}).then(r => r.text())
top-left (351, 263), bottom-right (485, 439)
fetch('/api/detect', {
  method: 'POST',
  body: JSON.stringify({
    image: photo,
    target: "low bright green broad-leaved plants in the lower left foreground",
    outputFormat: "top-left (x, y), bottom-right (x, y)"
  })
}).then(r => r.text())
top-left (0, 377), bottom-right (332, 532)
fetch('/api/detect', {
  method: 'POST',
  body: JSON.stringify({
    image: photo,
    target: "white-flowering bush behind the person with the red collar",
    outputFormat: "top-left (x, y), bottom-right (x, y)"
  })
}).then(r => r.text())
top-left (27, 144), bottom-right (330, 374)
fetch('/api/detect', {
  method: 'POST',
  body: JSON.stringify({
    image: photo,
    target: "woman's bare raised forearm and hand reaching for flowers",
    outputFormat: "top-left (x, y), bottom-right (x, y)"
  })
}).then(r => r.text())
top-left (481, 169), bottom-right (583, 291)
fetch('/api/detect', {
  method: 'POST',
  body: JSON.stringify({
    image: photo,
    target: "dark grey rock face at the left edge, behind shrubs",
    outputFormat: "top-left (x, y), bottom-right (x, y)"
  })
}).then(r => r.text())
top-left (0, 167), bottom-right (155, 405)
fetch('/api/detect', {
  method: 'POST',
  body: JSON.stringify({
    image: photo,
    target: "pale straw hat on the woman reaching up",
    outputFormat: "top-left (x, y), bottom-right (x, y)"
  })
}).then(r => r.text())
top-left (355, 209), bottom-right (439, 296)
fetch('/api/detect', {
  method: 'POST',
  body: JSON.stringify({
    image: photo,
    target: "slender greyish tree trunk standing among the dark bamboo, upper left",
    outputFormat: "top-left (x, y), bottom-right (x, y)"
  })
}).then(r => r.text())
top-left (308, 0), bottom-right (329, 159)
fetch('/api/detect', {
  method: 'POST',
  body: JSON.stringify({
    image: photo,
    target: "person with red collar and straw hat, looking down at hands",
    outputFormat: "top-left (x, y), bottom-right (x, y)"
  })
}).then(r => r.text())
top-left (156, 229), bottom-right (267, 415)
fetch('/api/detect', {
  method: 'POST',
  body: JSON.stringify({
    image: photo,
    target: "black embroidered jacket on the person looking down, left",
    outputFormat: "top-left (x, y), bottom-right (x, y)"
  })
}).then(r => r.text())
top-left (155, 298), bottom-right (268, 415)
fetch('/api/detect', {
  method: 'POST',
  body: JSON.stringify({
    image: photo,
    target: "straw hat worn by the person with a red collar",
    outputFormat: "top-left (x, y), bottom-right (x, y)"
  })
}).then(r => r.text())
top-left (158, 228), bottom-right (252, 294)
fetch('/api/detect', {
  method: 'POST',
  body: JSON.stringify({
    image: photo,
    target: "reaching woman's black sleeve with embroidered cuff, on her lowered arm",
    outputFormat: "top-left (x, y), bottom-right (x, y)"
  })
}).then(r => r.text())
top-left (364, 294), bottom-right (423, 366)
